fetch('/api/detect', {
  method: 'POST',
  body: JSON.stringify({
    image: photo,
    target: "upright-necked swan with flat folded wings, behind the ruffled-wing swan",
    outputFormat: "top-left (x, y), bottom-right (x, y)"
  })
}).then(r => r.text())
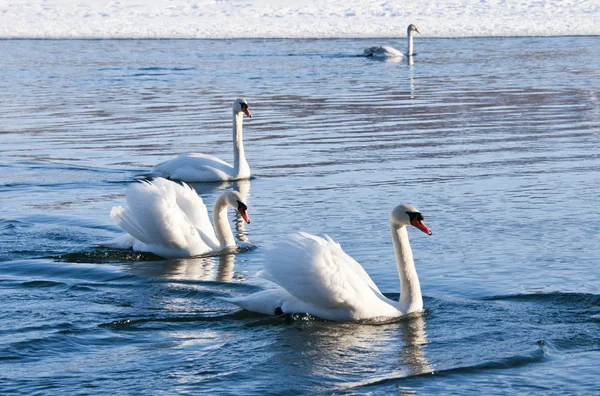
top-left (148, 98), bottom-right (252, 182)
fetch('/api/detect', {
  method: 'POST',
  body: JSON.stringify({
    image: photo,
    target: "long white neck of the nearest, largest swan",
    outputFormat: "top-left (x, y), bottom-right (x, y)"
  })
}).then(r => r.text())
top-left (390, 223), bottom-right (423, 314)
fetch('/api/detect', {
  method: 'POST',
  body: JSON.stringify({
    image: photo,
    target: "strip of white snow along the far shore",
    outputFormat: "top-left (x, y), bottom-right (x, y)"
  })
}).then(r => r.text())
top-left (0, 0), bottom-right (600, 38)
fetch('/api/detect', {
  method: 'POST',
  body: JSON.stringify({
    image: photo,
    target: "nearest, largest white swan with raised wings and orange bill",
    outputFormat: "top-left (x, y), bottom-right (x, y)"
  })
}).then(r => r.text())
top-left (225, 204), bottom-right (431, 321)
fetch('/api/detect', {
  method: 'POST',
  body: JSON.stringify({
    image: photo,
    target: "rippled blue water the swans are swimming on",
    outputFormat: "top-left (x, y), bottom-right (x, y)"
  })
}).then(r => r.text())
top-left (0, 37), bottom-right (600, 395)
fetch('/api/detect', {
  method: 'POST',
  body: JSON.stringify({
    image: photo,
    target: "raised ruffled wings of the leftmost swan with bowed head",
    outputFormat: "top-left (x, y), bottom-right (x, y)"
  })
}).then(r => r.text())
top-left (110, 180), bottom-right (211, 256)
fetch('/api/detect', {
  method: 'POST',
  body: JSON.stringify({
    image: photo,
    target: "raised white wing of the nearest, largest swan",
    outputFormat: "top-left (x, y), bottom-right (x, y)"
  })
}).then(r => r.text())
top-left (264, 233), bottom-right (380, 311)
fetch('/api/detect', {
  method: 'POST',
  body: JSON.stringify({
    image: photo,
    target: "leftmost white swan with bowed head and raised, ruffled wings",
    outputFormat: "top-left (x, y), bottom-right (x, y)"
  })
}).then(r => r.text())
top-left (104, 178), bottom-right (250, 258)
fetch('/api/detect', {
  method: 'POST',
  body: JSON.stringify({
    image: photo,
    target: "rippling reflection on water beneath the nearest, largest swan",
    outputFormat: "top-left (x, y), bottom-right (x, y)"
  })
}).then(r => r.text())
top-left (272, 315), bottom-right (433, 391)
